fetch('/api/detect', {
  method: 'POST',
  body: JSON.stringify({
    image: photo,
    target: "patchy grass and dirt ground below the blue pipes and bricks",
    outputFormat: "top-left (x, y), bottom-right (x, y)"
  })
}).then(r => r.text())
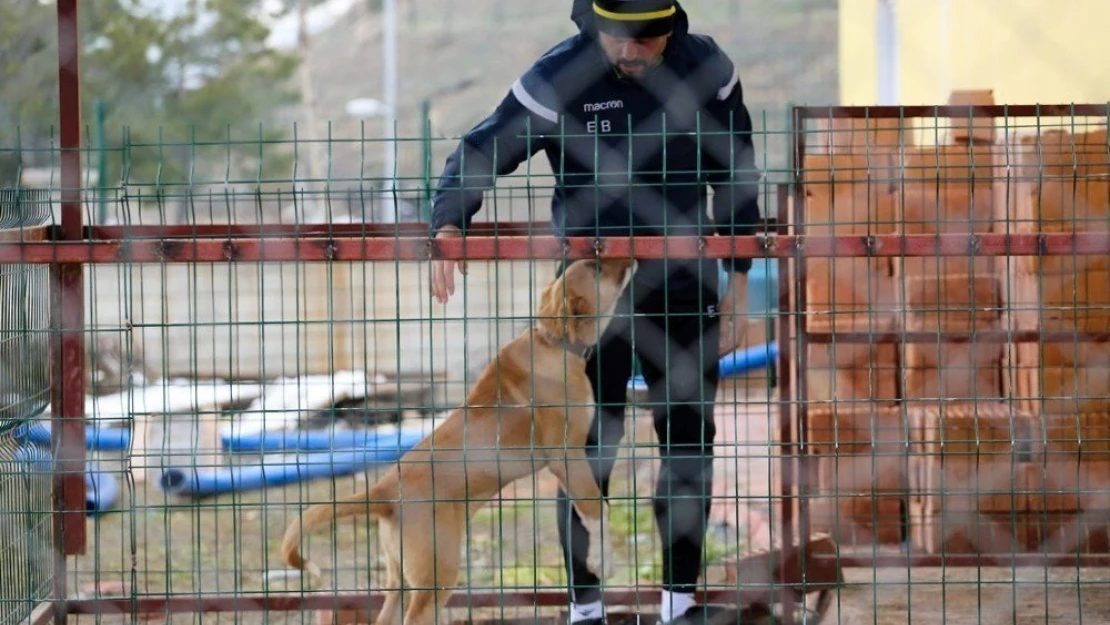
top-left (62, 384), bottom-right (1110, 624)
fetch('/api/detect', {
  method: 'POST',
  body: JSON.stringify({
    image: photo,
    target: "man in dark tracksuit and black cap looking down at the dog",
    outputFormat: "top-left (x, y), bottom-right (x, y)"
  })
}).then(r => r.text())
top-left (432, 0), bottom-right (759, 625)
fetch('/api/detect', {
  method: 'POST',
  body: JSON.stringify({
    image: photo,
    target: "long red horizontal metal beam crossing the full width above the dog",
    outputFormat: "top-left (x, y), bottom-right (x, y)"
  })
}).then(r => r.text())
top-left (0, 232), bottom-right (1110, 264)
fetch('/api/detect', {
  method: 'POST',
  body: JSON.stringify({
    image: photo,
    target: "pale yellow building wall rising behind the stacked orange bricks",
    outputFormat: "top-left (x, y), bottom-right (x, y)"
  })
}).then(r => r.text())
top-left (840, 0), bottom-right (1110, 105)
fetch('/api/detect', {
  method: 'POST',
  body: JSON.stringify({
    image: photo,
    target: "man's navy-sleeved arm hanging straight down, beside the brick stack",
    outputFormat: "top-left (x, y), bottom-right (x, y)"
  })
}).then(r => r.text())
top-left (702, 54), bottom-right (761, 274)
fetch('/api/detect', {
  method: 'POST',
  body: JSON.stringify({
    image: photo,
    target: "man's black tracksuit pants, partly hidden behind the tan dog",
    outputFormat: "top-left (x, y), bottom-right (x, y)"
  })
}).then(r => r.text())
top-left (557, 275), bottom-right (720, 604)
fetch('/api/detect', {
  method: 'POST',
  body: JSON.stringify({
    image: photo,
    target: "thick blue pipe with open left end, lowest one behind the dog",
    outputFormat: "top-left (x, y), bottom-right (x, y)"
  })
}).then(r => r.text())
top-left (159, 429), bottom-right (427, 497)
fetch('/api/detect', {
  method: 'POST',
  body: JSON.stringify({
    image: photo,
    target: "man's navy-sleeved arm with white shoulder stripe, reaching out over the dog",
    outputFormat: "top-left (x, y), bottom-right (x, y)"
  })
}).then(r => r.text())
top-left (432, 82), bottom-right (551, 233)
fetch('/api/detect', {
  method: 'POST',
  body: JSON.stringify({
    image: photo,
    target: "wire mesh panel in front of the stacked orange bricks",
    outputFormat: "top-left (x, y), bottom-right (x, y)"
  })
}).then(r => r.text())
top-left (794, 102), bottom-right (1110, 622)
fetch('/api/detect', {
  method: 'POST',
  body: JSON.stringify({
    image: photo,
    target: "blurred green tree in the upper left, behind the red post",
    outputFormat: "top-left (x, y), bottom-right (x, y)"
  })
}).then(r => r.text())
top-left (0, 0), bottom-right (297, 197)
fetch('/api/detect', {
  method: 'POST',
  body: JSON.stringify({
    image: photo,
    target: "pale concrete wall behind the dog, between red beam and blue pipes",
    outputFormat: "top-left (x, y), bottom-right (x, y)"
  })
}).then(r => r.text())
top-left (85, 262), bottom-right (554, 401)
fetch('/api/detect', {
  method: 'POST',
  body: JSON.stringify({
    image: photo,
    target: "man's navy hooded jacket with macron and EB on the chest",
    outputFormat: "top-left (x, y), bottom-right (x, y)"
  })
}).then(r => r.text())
top-left (432, 0), bottom-right (760, 289)
